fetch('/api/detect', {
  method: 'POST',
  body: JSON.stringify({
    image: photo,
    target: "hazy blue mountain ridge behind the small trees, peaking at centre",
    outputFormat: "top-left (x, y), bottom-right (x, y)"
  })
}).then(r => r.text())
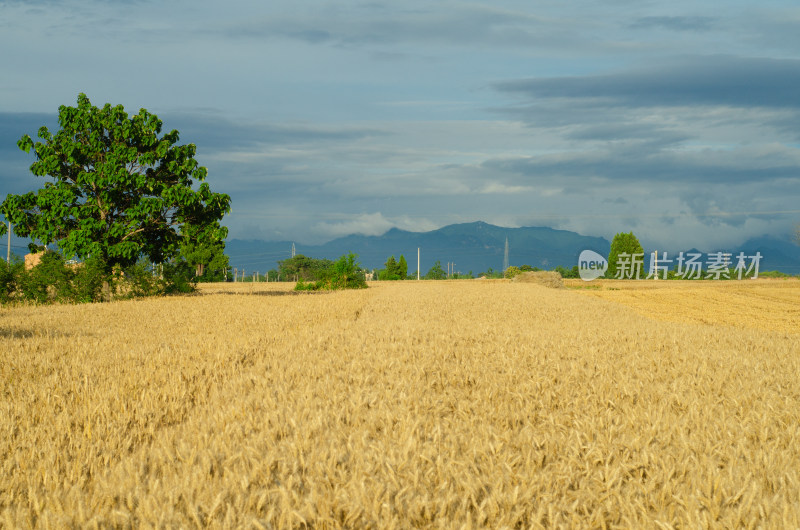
top-left (225, 221), bottom-right (610, 274)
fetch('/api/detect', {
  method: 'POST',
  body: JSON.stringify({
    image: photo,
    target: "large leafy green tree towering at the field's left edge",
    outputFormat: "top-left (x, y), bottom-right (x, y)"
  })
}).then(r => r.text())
top-left (0, 94), bottom-right (230, 285)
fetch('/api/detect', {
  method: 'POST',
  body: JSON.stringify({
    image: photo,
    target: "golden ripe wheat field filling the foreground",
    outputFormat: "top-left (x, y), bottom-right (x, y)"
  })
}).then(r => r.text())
top-left (0, 281), bottom-right (800, 528)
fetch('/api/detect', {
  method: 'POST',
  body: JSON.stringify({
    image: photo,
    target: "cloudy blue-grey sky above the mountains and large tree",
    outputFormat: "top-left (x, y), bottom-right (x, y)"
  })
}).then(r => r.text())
top-left (0, 0), bottom-right (800, 250)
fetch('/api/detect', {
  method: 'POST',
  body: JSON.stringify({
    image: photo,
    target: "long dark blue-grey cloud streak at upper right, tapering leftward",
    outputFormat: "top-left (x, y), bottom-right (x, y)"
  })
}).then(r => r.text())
top-left (495, 56), bottom-right (800, 108)
